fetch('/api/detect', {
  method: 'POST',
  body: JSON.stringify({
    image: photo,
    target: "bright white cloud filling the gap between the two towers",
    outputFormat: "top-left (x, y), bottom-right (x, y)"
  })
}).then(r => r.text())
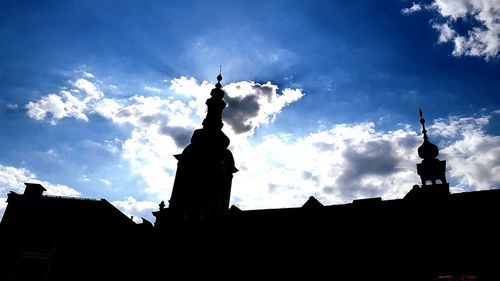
top-left (232, 123), bottom-right (419, 209)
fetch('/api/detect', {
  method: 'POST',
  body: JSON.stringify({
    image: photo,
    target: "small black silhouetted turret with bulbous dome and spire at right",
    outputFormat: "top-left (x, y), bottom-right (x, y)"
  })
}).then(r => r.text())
top-left (417, 108), bottom-right (449, 193)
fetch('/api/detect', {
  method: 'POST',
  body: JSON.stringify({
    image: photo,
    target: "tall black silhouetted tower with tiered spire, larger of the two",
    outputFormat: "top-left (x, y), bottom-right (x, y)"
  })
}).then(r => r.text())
top-left (169, 72), bottom-right (238, 222)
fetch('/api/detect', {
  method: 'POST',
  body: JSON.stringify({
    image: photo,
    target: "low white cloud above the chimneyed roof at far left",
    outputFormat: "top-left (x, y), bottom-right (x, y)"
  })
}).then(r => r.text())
top-left (0, 164), bottom-right (80, 220)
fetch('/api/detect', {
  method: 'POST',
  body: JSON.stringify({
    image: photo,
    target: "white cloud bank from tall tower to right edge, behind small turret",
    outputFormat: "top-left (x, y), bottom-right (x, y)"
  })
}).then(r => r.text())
top-left (232, 111), bottom-right (500, 209)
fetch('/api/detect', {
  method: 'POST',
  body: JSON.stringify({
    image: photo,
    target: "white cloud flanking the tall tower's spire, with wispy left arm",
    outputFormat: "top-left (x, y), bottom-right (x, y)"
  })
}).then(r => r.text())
top-left (26, 73), bottom-right (303, 206)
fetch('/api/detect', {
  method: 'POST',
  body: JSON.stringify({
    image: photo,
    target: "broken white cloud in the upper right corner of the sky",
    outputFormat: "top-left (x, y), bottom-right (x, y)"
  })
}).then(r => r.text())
top-left (402, 0), bottom-right (500, 60)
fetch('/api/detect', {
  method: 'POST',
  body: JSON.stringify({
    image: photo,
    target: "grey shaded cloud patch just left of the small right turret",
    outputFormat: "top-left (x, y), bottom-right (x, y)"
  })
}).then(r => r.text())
top-left (337, 140), bottom-right (400, 199)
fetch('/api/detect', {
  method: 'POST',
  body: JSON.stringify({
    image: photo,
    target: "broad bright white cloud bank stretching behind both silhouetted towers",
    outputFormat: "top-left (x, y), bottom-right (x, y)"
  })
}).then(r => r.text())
top-left (24, 72), bottom-right (500, 212)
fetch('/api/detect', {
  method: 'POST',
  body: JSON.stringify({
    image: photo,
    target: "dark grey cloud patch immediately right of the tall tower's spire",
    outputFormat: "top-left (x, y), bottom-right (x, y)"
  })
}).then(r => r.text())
top-left (223, 93), bottom-right (259, 134)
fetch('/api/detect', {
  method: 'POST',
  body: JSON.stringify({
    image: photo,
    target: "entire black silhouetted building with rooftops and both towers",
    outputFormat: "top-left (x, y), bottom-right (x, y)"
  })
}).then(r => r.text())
top-left (0, 74), bottom-right (500, 280)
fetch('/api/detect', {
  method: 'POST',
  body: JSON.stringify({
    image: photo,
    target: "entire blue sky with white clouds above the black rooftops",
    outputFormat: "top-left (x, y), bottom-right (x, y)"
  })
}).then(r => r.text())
top-left (0, 0), bottom-right (500, 219)
